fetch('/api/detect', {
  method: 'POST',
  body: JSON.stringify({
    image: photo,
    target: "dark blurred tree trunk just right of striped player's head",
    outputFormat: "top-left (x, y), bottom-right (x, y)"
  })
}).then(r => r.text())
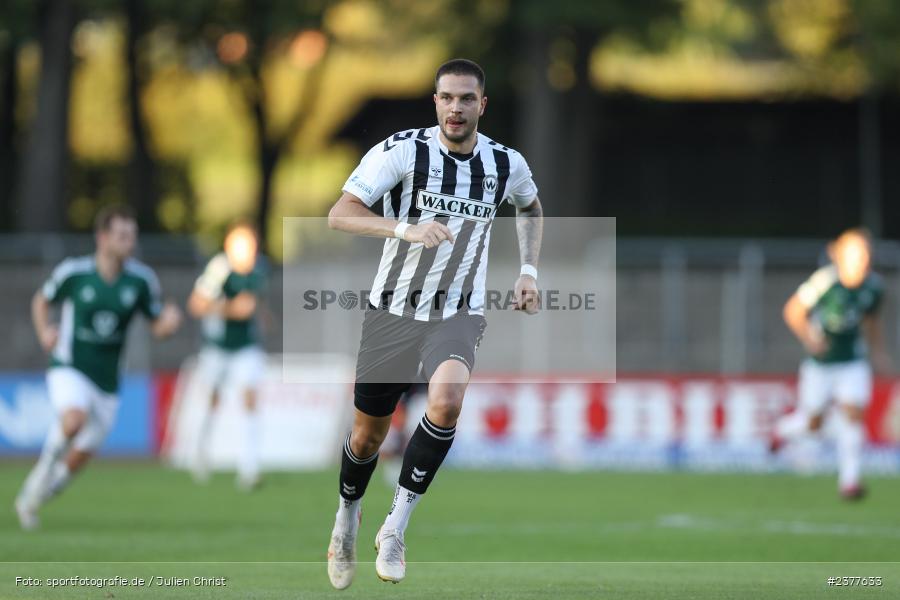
top-left (502, 0), bottom-right (679, 216)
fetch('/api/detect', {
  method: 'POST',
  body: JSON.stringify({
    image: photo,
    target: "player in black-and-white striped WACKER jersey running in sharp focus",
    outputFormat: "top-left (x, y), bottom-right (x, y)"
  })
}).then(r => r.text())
top-left (328, 59), bottom-right (542, 589)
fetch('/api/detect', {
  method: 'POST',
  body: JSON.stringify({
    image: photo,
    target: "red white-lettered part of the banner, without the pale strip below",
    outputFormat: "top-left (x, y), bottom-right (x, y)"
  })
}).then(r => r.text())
top-left (464, 375), bottom-right (900, 444)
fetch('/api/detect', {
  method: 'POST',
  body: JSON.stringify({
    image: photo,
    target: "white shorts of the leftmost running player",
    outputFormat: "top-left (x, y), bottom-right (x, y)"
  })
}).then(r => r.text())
top-left (47, 367), bottom-right (119, 452)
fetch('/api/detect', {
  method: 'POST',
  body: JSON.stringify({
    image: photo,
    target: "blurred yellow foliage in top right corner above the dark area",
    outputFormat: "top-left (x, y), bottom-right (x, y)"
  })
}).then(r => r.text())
top-left (592, 0), bottom-right (900, 100)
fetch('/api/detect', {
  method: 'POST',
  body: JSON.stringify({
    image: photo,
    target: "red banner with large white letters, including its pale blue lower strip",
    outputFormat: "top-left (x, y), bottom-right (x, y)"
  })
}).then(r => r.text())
top-left (152, 373), bottom-right (900, 471)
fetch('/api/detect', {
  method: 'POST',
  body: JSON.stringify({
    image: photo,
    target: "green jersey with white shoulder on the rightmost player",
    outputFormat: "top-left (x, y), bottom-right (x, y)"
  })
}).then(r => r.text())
top-left (797, 265), bottom-right (884, 363)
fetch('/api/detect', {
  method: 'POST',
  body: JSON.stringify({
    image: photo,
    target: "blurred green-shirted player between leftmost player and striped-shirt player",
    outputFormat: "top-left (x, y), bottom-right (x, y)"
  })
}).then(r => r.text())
top-left (188, 223), bottom-right (266, 490)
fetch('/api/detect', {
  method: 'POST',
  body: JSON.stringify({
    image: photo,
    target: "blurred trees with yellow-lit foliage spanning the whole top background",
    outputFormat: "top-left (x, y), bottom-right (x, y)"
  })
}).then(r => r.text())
top-left (0, 0), bottom-right (900, 238)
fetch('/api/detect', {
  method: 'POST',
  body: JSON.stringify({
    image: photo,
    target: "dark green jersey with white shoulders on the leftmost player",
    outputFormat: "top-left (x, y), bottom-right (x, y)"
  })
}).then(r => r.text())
top-left (42, 255), bottom-right (162, 393)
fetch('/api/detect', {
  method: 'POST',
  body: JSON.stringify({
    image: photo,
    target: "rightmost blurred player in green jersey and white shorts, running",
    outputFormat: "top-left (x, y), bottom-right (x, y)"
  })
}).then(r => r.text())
top-left (772, 229), bottom-right (890, 499)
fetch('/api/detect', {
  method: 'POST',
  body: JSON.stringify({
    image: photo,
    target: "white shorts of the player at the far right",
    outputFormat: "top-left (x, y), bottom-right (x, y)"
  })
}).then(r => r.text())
top-left (797, 359), bottom-right (872, 414)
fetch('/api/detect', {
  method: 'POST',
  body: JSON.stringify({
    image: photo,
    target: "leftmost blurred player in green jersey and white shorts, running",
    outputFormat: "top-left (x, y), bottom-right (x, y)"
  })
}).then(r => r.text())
top-left (15, 206), bottom-right (181, 529)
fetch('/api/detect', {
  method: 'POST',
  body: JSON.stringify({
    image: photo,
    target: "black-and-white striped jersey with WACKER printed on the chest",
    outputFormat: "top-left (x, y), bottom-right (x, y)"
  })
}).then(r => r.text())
top-left (343, 126), bottom-right (537, 321)
